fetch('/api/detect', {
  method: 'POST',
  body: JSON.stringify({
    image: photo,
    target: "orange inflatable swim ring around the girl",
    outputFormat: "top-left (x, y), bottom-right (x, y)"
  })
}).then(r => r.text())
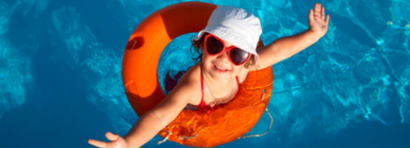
top-left (122, 2), bottom-right (273, 147)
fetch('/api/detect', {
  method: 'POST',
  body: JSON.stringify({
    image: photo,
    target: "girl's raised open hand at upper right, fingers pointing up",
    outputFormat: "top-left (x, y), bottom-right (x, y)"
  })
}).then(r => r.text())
top-left (309, 3), bottom-right (329, 37)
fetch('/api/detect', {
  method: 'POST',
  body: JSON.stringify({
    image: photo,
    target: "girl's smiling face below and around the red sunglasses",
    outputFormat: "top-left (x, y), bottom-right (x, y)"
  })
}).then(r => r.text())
top-left (201, 40), bottom-right (245, 81)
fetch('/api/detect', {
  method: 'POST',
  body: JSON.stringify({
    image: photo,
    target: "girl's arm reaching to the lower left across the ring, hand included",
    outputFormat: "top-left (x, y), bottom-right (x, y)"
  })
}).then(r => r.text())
top-left (88, 74), bottom-right (198, 148)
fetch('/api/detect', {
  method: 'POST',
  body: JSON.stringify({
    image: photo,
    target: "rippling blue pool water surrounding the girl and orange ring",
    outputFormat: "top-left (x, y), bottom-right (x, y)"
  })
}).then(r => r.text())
top-left (0, 0), bottom-right (410, 148)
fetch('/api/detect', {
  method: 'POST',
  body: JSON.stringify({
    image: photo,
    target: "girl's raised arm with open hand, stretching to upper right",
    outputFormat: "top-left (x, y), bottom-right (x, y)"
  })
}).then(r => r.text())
top-left (253, 3), bottom-right (329, 70)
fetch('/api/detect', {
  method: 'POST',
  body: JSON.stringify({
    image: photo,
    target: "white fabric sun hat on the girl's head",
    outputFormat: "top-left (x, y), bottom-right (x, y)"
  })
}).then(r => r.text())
top-left (194, 6), bottom-right (262, 64)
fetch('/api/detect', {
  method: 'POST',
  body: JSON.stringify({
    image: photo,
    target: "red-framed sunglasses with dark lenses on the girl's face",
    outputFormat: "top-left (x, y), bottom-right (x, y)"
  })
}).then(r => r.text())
top-left (204, 34), bottom-right (252, 66)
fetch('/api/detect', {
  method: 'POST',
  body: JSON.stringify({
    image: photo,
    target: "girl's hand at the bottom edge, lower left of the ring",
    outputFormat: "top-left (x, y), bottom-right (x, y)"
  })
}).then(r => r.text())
top-left (88, 132), bottom-right (128, 148)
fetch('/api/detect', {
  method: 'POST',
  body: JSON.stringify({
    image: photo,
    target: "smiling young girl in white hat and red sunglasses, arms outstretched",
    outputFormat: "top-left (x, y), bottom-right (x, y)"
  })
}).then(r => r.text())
top-left (88, 3), bottom-right (329, 148)
